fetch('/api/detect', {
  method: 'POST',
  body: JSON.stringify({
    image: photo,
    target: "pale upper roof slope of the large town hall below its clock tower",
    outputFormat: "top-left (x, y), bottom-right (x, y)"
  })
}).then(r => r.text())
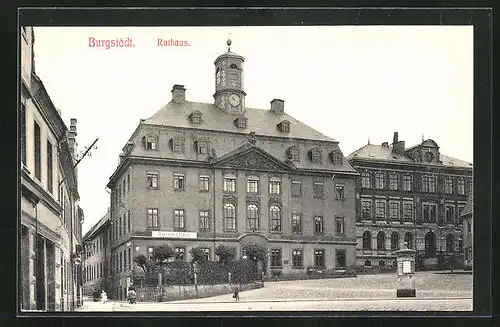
top-left (143, 101), bottom-right (337, 142)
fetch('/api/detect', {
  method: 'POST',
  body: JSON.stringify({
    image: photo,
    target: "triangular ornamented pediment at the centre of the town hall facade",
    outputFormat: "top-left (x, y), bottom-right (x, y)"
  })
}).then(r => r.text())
top-left (215, 147), bottom-right (292, 172)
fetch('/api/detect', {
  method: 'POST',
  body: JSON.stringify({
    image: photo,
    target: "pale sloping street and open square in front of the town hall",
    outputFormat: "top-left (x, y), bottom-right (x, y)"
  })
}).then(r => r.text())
top-left (80, 272), bottom-right (472, 312)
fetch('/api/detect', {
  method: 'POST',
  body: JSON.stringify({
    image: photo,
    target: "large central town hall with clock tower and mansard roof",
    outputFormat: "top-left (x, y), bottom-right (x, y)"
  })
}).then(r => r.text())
top-left (104, 39), bottom-right (358, 298)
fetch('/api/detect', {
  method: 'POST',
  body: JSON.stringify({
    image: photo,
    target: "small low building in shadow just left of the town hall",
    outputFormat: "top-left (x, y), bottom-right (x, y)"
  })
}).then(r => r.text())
top-left (83, 209), bottom-right (111, 296)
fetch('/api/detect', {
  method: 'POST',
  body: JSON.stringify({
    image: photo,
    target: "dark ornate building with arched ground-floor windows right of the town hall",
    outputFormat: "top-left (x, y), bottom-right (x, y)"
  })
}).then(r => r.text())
top-left (347, 132), bottom-right (473, 268)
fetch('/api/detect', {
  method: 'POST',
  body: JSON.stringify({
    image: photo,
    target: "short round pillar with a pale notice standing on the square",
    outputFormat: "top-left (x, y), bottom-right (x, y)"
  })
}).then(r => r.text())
top-left (396, 242), bottom-right (417, 297)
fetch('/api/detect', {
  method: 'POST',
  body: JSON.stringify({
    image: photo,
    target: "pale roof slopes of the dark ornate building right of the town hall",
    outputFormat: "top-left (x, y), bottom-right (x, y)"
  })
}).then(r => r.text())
top-left (347, 144), bottom-right (472, 168)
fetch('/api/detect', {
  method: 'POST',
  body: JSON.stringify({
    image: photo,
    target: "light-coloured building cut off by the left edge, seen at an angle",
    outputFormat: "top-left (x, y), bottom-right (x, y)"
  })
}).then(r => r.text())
top-left (19, 27), bottom-right (83, 311)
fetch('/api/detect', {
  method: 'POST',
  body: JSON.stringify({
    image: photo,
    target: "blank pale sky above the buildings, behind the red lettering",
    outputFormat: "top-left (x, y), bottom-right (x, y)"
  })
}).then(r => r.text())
top-left (34, 26), bottom-right (473, 233)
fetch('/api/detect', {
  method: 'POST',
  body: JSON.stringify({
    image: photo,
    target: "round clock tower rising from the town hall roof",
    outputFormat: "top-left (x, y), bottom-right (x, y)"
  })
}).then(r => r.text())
top-left (214, 40), bottom-right (246, 115)
